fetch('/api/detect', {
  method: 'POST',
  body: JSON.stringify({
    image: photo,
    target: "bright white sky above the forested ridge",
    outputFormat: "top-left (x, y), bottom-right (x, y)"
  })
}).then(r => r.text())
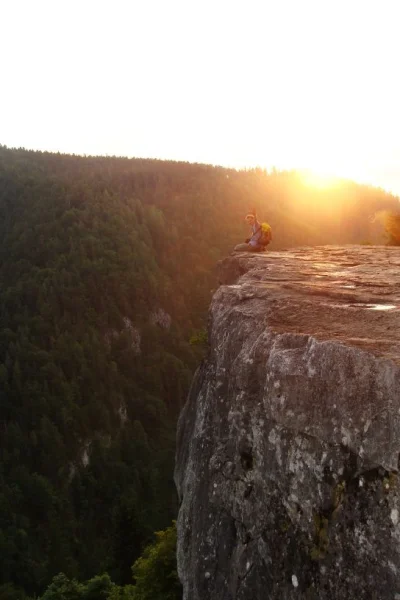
top-left (0, 0), bottom-right (400, 194)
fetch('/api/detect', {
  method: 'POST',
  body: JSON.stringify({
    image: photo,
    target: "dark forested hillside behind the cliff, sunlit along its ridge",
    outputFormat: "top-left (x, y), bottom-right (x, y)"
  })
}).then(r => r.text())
top-left (0, 147), bottom-right (398, 597)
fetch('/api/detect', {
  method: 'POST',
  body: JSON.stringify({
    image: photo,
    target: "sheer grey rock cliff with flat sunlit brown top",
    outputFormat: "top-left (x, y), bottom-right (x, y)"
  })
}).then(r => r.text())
top-left (176, 247), bottom-right (400, 600)
